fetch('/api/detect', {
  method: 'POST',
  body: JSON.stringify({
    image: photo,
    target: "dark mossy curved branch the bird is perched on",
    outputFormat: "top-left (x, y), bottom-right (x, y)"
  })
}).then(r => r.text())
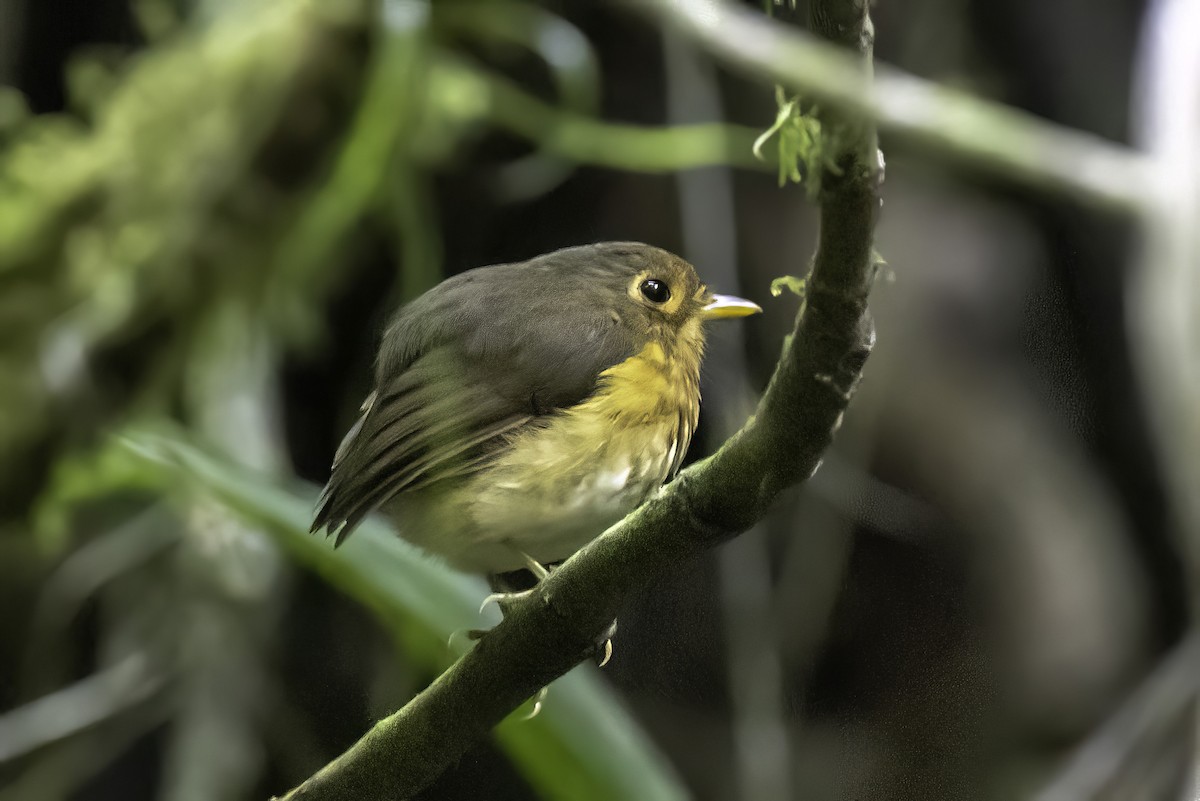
top-left (274, 0), bottom-right (881, 801)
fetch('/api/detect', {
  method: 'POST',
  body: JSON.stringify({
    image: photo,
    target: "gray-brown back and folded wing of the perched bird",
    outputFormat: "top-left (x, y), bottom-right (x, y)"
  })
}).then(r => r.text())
top-left (313, 246), bottom-right (638, 542)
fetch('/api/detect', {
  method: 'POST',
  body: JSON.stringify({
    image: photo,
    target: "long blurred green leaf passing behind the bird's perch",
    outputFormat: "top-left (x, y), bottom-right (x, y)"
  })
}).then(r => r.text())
top-left (122, 430), bottom-right (688, 801)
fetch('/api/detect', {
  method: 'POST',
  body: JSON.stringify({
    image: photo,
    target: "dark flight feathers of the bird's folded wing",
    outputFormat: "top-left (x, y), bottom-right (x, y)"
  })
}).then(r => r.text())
top-left (312, 348), bottom-right (533, 544)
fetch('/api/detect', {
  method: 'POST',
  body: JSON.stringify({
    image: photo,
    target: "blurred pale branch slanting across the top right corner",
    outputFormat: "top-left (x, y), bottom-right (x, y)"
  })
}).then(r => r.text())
top-left (637, 0), bottom-right (1152, 213)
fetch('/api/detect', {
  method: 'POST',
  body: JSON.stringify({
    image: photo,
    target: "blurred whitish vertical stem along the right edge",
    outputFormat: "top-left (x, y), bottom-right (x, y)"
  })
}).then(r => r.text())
top-left (1129, 0), bottom-right (1200, 612)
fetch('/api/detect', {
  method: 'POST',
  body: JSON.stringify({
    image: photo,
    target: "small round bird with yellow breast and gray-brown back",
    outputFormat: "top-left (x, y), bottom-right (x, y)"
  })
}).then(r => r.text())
top-left (312, 242), bottom-right (762, 585)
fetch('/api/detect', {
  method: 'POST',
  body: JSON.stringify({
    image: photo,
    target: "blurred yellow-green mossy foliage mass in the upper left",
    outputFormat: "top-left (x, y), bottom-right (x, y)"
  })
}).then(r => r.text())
top-left (0, 4), bottom-right (367, 511)
